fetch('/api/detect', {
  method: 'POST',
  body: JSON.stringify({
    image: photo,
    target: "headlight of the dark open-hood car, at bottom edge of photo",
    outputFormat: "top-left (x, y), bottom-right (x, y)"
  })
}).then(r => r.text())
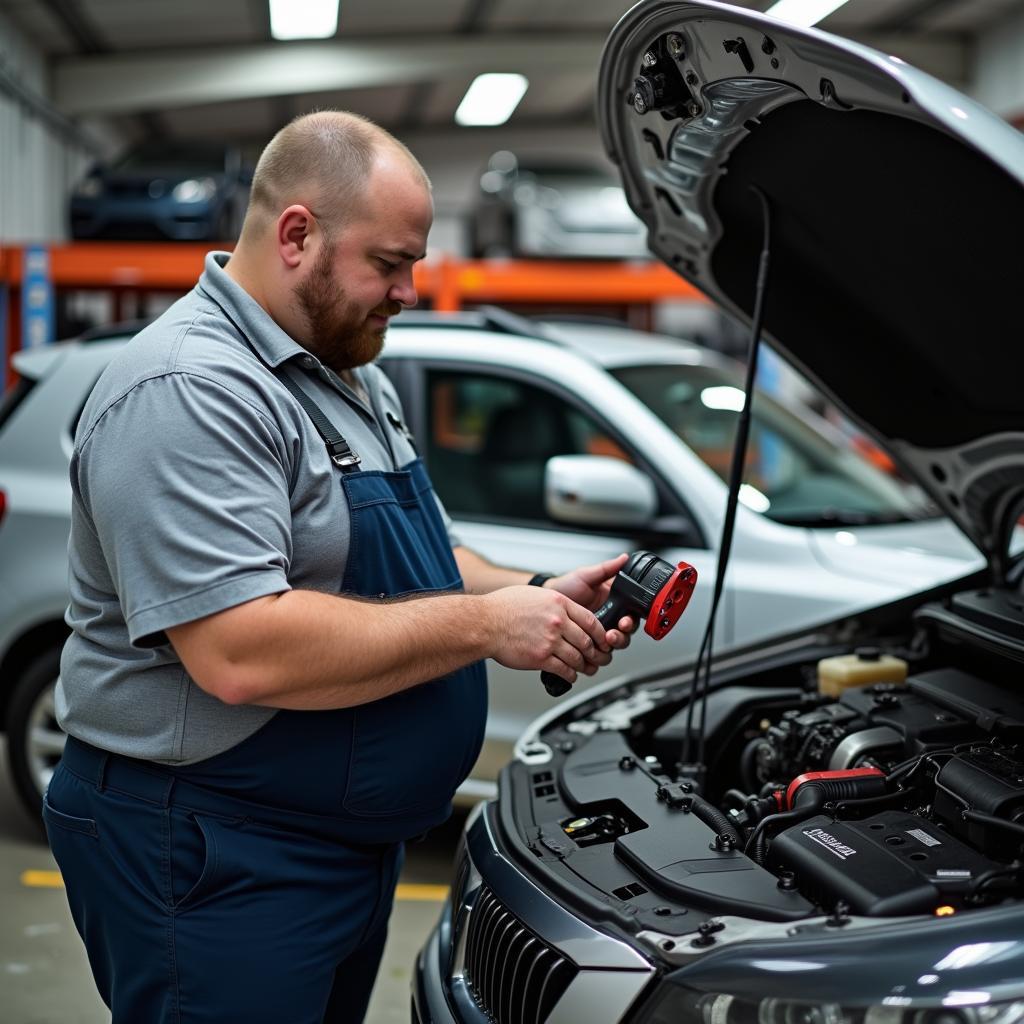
top-left (640, 984), bottom-right (1024, 1024)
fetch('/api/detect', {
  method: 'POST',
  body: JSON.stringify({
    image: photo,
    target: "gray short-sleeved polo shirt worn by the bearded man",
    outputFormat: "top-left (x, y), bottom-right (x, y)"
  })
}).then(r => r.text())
top-left (56, 253), bottom-right (458, 764)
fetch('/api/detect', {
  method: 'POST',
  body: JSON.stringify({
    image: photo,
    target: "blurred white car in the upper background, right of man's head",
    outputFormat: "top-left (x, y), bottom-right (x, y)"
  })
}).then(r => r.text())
top-left (469, 150), bottom-right (650, 259)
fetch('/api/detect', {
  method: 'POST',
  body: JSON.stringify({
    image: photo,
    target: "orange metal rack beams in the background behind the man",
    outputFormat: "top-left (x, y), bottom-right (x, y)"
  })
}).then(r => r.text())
top-left (0, 242), bottom-right (703, 378)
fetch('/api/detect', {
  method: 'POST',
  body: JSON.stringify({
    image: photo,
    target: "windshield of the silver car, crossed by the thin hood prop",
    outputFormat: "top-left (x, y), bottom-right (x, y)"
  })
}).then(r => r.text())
top-left (610, 364), bottom-right (936, 526)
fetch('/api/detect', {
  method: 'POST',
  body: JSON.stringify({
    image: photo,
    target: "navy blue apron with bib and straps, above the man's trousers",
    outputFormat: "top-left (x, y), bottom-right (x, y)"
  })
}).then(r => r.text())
top-left (161, 348), bottom-right (486, 843)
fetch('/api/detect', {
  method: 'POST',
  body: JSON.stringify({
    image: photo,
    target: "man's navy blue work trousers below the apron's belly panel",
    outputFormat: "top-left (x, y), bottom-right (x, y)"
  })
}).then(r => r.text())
top-left (43, 739), bottom-right (402, 1024)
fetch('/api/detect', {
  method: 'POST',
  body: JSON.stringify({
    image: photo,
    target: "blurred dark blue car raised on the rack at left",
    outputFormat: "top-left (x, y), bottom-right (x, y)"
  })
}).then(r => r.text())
top-left (71, 141), bottom-right (252, 242)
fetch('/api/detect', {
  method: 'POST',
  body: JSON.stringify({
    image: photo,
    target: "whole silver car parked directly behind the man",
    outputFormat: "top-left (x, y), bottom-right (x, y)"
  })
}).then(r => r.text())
top-left (0, 310), bottom-right (981, 823)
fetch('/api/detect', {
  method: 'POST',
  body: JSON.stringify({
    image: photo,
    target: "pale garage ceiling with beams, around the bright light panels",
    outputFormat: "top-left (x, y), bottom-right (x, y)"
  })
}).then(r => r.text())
top-left (0, 0), bottom-right (1022, 143)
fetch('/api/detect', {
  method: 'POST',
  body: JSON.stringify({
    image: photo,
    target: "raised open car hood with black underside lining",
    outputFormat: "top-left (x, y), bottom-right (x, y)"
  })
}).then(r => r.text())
top-left (599, 0), bottom-right (1024, 577)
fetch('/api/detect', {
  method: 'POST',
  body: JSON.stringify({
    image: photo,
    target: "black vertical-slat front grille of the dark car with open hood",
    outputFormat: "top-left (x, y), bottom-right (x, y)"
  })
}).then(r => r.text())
top-left (465, 886), bottom-right (577, 1024)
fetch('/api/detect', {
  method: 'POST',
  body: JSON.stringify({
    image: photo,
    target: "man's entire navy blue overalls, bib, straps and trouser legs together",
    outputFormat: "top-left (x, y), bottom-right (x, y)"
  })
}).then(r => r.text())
top-left (43, 325), bottom-right (486, 1024)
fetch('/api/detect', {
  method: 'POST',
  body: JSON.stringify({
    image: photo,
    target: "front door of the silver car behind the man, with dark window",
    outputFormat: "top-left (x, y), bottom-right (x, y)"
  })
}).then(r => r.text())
top-left (384, 359), bottom-right (726, 774)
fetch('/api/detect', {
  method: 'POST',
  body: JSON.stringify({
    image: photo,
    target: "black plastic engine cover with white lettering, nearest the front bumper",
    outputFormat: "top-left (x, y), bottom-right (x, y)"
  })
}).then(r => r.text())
top-left (769, 811), bottom-right (1000, 916)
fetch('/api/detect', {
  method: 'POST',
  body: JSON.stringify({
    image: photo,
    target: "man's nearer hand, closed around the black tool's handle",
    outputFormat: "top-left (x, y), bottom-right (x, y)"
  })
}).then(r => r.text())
top-left (483, 587), bottom-right (610, 683)
